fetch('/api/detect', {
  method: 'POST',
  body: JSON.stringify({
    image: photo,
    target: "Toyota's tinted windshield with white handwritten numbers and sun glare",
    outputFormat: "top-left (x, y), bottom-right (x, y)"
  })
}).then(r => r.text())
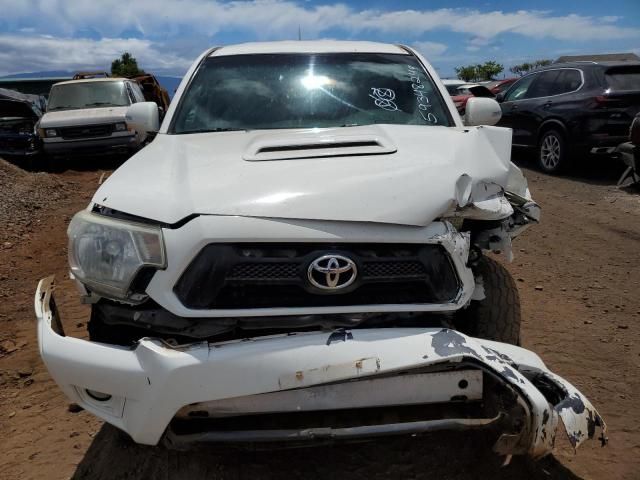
top-left (171, 53), bottom-right (451, 133)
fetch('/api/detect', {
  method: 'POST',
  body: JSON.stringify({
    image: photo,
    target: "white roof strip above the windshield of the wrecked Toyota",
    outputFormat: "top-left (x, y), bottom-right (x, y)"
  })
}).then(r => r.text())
top-left (209, 40), bottom-right (409, 57)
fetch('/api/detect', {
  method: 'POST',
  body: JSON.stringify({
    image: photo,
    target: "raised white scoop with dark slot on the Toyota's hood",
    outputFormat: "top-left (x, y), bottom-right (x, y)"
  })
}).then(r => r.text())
top-left (243, 128), bottom-right (398, 162)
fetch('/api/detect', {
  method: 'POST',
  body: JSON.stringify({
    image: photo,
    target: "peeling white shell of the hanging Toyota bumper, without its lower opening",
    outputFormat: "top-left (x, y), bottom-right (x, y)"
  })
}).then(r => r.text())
top-left (35, 277), bottom-right (606, 458)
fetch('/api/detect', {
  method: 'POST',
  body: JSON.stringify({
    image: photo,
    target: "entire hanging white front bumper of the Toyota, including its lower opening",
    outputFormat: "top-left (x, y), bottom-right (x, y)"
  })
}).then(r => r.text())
top-left (35, 277), bottom-right (606, 458)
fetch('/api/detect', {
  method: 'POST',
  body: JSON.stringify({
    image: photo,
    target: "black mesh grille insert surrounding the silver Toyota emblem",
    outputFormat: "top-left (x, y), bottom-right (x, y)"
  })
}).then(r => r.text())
top-left (174, 244), bottom-right (460, 309)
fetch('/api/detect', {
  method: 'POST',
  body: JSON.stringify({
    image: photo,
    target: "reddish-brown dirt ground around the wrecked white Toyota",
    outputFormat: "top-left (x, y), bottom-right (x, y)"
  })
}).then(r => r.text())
top-left (0, 153), bottom-right (640, 480)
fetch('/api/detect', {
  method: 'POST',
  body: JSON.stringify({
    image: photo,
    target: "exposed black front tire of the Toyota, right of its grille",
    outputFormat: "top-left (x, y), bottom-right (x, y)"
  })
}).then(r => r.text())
top-left (455, 257), bottom-right (520, 345)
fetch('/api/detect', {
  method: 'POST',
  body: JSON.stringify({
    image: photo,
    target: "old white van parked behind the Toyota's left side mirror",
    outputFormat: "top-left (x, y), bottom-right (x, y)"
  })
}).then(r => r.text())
top-left (38, 78), bottom-right (148, 156)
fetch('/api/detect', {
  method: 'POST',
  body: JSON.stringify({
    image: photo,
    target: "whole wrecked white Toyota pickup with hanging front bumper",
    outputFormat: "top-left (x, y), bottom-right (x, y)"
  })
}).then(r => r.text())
top-left (35, 41), bottom-right (605, 458)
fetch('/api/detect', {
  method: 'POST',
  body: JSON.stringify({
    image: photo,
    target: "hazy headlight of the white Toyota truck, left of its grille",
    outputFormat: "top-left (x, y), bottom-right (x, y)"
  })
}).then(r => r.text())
top-left (67, 211), bottom-right (166, 303)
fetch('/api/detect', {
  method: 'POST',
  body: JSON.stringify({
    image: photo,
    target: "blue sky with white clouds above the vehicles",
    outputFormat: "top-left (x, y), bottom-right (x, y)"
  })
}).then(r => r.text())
top-left (0, 0), bottom-right (640, 77)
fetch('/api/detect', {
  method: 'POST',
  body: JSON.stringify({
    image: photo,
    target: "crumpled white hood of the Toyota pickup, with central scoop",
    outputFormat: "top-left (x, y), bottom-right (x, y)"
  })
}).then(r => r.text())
top-left (93, 125), bottom-right (517, 226)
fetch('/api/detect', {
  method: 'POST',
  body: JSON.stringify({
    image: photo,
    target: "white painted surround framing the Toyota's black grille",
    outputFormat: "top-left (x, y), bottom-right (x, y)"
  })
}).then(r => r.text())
top-left (147, 218), bottom-right (474, 318)
